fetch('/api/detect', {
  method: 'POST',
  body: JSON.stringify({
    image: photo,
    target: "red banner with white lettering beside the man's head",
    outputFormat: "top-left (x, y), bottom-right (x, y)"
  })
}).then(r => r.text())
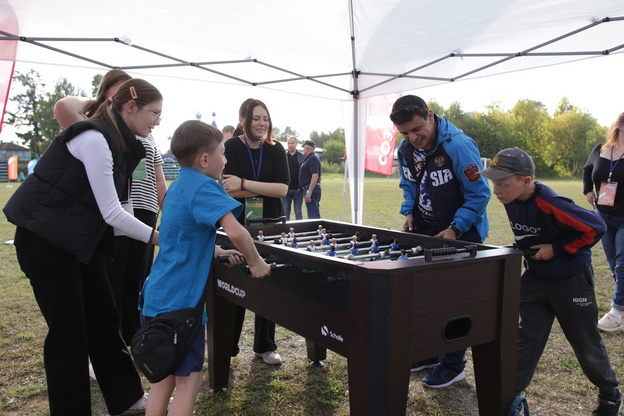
top-left (364, 93), bottom-right (401, 176)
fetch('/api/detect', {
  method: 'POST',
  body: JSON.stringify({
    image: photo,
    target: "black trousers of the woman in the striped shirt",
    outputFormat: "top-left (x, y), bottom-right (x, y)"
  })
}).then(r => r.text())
top-left (106, 209), bottom-right (156, 346)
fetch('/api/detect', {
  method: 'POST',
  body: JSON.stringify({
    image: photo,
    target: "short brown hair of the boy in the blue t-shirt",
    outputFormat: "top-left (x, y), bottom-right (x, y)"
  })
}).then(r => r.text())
top-left (171, 120), bottom-right (223, 167)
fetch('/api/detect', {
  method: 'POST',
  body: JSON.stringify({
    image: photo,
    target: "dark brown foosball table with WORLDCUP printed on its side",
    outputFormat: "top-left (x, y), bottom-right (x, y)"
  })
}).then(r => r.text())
top-left (207, 220), bottom-right (522, 416)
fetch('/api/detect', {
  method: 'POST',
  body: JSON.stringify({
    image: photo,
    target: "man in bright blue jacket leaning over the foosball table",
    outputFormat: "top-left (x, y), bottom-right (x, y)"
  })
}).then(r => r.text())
top-left (390, 95), bottom-right (491, 388)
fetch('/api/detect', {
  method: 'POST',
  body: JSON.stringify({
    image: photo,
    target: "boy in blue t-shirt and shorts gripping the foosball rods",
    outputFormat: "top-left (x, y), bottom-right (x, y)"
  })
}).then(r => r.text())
top-left (142, 120), bottom-right (271, 415)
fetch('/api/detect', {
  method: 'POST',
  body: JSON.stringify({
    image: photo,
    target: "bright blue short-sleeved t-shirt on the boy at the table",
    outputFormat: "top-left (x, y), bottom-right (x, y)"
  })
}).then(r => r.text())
top-left (143, 168), bottom-right (242, 319)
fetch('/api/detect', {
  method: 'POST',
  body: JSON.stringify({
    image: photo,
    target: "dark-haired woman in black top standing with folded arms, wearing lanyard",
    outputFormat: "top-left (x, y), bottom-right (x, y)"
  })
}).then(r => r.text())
top-left (222, 98), bottom-right (290, 364)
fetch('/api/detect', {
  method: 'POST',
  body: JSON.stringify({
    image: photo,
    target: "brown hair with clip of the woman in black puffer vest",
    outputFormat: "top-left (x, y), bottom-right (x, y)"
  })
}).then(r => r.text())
top-left (92, 78), bottom-right (162, 151)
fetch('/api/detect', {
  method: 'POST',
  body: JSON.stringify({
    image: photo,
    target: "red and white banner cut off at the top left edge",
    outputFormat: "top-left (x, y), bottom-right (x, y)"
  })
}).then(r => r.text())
top-left (0, 0), bottom-right (19, 132)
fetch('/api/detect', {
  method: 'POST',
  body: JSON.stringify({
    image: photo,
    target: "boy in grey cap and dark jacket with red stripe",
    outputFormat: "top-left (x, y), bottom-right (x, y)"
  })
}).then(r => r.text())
top-left (479, 148), bottom-right (622, 416)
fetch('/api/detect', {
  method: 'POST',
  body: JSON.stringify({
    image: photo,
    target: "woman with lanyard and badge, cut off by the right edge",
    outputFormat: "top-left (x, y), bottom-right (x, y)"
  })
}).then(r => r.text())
top-left (583, 113), bottom-right (624, 331)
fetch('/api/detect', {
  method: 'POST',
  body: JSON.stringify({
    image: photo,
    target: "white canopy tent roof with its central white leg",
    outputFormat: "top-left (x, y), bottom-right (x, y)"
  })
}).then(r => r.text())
top-left (0, 0), bottom-right (624, 223)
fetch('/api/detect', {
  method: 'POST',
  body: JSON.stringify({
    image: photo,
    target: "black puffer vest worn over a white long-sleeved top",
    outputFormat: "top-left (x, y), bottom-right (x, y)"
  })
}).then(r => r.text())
top-left (3, 113), bottom-right (145, 264)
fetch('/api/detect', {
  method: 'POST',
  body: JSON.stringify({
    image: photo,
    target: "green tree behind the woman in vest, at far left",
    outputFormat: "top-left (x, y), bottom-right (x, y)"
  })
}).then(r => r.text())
top-left (6, 70), bottom-right (84, 155)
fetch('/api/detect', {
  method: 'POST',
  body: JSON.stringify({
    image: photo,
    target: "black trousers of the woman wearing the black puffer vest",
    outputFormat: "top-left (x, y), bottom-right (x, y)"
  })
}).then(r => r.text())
top-left (15, 227), bottom-right (143, 416)
